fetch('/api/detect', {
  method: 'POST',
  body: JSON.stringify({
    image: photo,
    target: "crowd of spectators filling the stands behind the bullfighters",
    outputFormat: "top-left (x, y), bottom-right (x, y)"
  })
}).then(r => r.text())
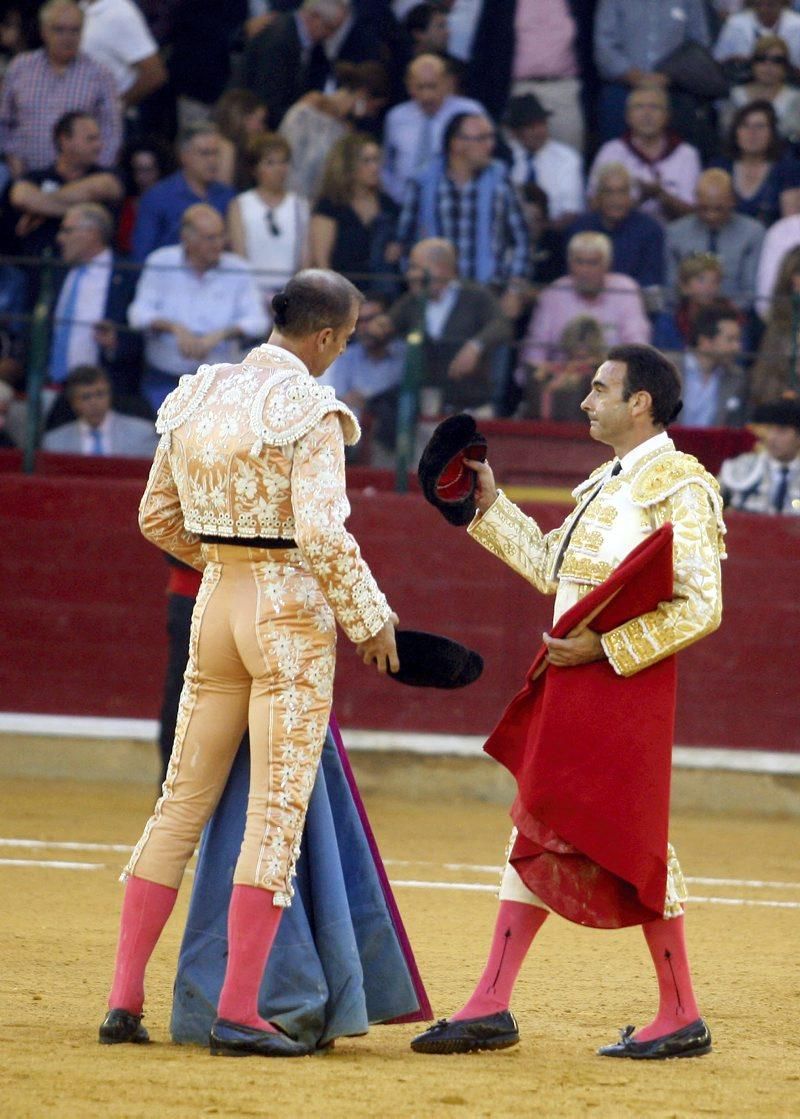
top-left (0, 0), bottom-right (800, 511)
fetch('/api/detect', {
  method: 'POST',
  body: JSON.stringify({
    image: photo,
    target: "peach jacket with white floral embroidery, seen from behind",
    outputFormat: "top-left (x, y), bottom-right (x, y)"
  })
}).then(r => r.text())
top-left (139, 344), bottom-right (390, 641)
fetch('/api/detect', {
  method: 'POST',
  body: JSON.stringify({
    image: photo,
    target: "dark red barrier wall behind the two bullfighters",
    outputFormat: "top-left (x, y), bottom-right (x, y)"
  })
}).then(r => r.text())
top-left (0, 473), bottom-right (800, 750)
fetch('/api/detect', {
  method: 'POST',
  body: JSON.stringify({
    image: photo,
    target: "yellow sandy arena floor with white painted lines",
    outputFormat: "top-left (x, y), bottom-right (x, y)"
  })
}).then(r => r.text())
top-left (0, 780), bottom-right (800, 1119)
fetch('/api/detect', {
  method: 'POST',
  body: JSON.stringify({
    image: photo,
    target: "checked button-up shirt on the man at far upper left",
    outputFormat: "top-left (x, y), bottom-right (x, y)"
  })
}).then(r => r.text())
top-left (0, 49), bottom-right (122, 171)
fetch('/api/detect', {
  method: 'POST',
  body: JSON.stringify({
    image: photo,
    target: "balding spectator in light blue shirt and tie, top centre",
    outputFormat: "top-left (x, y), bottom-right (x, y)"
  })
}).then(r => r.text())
top-left (382, 55), bottom-right (483, 205)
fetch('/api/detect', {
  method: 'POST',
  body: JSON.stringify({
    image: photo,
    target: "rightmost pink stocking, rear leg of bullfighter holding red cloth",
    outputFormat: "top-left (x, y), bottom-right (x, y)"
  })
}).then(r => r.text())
top-left (633, 916), bottom-right (700, 1042)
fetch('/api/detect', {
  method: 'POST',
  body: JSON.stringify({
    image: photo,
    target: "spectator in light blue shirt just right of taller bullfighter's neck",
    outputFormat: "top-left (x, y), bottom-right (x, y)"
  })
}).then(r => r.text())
top-left (320, 293), bottom-right (405, 466)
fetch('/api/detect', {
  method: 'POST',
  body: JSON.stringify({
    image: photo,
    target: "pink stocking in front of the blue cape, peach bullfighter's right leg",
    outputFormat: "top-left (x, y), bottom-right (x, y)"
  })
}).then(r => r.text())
top-left (218, 886), bottom-right (283, 1033)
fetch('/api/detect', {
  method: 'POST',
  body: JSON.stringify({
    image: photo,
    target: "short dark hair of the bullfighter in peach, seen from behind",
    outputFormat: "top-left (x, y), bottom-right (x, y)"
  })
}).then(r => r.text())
top-left (272, 269), bottom-right (364, 338)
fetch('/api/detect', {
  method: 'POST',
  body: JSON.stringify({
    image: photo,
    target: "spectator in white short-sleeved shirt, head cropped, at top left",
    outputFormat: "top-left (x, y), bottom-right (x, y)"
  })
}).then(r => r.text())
top-left (81, 0), bottom-right (167, 120)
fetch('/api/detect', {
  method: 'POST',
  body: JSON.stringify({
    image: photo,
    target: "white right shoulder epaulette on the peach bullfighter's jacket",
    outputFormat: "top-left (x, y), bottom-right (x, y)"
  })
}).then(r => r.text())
top-left (250, 368), bottom-right (361, 454)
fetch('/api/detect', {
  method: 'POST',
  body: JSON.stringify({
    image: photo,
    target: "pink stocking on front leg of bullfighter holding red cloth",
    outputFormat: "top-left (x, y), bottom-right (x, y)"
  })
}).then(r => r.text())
top-left (450, 901), bottom-right (547, 1022)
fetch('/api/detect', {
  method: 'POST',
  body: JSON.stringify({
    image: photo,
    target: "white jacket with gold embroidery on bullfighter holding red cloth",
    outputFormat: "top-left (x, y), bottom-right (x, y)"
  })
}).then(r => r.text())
top-left (468, 433), bottom-right (725, 676)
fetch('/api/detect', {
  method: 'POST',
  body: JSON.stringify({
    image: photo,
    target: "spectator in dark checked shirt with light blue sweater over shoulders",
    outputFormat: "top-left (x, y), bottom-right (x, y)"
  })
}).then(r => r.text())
top-left (397, 113), bottom-right (530, 292)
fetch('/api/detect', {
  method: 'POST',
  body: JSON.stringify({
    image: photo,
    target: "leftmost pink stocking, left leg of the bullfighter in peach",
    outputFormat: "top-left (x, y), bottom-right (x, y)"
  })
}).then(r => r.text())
top-left (109, 875), bottom-right (178, 1014)
